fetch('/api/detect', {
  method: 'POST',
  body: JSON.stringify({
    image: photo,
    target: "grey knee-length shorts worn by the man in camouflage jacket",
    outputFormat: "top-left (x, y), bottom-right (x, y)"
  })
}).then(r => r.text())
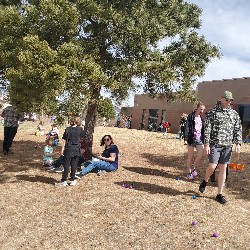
top-left (209, 145), bottom-right (232, 164)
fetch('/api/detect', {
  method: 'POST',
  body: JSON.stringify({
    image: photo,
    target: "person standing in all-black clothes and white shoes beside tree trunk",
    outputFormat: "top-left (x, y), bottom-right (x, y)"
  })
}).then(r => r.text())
top-left (56, 117), bottom-right (84, 186)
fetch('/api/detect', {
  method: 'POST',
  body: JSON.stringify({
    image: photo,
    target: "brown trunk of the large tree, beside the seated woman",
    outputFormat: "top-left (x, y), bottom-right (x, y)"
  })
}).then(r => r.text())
top-left (84, 90), bottom-right (100, 158)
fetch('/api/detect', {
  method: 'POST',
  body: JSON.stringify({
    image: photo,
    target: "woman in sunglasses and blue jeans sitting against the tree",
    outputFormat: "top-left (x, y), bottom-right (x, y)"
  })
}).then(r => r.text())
top-left (76, 135), bottom-right (119, 179)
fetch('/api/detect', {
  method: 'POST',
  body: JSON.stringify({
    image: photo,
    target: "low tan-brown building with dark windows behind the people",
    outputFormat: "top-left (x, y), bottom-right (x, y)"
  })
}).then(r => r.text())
top-left (130, 77), bottom-right (250, 136)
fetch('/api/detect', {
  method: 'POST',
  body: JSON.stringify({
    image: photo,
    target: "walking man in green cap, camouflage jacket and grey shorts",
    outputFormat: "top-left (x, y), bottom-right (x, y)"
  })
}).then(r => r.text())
top-left (199, 91), bottom-right (242, 204)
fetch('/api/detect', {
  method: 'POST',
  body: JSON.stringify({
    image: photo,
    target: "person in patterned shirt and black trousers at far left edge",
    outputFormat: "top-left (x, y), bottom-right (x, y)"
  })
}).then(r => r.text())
top-left (1, 105), bottom-right (19, 155)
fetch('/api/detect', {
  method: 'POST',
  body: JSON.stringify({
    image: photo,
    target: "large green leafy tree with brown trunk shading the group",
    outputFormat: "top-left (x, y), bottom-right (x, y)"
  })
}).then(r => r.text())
top-left (0, 0), bottom-right (220, 150)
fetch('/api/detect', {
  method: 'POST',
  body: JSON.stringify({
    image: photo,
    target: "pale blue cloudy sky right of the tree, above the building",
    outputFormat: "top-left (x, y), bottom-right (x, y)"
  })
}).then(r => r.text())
top-left (125, 0), bottom-right (250, 106)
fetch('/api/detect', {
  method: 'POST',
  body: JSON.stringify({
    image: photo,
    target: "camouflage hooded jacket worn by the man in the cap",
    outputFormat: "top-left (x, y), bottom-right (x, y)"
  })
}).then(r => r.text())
top-left (204, 101), bottom-right (242, 146)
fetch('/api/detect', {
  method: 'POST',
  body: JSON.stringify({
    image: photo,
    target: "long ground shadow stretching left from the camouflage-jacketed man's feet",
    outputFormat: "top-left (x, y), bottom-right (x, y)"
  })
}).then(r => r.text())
top-left (115, 181), bottom-right (200, 197)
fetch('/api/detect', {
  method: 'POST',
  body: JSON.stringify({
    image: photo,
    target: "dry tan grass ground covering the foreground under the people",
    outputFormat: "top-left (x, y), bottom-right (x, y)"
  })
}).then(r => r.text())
top-left (0, 122), bottom-right (250, 250)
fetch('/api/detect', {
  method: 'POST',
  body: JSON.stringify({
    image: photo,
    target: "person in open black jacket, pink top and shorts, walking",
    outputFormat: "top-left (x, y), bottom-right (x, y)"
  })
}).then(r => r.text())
top-left (184, 102), bottom-right (205, 180)
